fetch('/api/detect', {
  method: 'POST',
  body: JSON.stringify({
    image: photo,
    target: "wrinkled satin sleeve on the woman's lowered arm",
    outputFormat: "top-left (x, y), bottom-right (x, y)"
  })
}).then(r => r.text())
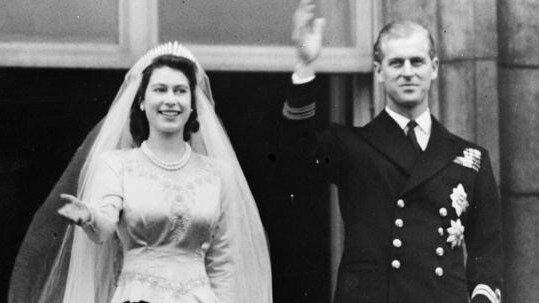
top-left (205, 164), bottom-right (234, 303)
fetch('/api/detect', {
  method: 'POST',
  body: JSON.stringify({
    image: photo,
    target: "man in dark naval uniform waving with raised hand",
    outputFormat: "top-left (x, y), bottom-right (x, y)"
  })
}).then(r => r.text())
top-left (282, 0), bottom-right (502, 303)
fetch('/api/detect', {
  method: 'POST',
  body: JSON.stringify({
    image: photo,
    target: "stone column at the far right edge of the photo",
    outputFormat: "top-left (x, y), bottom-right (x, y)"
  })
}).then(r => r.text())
top-left (498, 0), bottom-right (539, 303)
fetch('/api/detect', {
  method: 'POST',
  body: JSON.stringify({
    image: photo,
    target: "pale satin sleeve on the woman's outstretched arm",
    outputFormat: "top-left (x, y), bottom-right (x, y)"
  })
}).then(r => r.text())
top-left (82, 153), bottom-right (123, 243)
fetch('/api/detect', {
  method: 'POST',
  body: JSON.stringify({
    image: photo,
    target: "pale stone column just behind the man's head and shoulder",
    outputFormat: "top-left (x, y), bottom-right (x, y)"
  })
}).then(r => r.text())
top-left (438, 0), bottom-right (499, 176)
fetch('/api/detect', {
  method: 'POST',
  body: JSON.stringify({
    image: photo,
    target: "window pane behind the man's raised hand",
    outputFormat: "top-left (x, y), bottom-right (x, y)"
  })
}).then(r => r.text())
top-left (159, 0), bottom-right (352, 46)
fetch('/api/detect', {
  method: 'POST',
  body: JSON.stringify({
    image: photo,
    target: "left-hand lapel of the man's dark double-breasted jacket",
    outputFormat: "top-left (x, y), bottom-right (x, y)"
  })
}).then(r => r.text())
top-left (362, 110), bottom-right (415, 175)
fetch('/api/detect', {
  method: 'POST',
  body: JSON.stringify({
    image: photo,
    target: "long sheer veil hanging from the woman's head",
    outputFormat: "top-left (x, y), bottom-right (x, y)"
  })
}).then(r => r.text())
top-left (9, 42), bottom-right (272, 303)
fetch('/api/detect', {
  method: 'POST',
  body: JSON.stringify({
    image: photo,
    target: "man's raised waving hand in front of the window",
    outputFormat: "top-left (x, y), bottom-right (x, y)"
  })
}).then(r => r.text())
top-left (292, 0), bottom-right (325, 65)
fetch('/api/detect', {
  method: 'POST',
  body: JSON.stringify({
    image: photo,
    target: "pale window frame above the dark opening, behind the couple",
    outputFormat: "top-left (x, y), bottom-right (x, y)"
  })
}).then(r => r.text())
top-left (0, 0), bottom-right (381, 73)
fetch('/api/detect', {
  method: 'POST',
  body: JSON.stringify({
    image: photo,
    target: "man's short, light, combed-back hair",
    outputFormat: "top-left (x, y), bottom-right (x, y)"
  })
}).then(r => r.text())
top-left (374, 21), bottom-right (436, 63)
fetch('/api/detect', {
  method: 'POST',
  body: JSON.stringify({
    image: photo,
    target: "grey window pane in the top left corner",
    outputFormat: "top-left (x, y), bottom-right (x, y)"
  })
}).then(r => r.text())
top-left (0, 0), bottom-right (118, 44)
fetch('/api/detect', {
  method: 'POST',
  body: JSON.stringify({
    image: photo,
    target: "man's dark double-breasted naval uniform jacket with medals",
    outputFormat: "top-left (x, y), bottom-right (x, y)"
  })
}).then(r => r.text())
top-left (281, 83), bottom-right (502, 303)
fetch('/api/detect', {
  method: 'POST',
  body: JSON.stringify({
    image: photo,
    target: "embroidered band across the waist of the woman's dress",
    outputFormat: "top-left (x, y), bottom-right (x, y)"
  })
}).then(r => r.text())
top-left (120, 271), bottom-right (210, 299)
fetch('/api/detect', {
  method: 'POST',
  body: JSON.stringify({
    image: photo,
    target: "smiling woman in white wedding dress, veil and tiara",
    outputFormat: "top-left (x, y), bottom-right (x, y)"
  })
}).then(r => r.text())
top-left (9, 42), bottom-right (272, 303)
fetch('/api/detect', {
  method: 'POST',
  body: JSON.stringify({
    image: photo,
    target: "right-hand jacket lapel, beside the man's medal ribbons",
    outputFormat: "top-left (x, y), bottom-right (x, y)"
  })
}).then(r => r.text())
top-left (401, 117), bottom-right (463, 195)
